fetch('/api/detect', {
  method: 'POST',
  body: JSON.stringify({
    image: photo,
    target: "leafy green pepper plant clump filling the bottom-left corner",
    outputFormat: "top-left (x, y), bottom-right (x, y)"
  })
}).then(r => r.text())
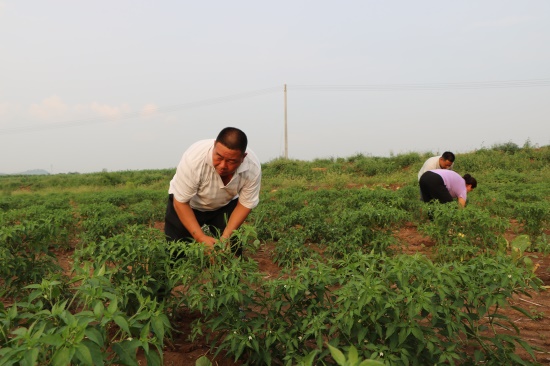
top-left (0, 264), bottom-right (170, 365)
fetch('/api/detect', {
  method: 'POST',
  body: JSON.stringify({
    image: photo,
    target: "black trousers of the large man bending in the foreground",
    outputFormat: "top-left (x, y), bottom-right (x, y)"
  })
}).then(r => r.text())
top-left (164, 194), bottom-right (242, 256)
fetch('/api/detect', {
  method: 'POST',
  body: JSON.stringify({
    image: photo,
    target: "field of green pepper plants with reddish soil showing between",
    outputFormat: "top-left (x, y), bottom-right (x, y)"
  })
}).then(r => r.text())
top-left (0, 142), bottom-right (550, 366)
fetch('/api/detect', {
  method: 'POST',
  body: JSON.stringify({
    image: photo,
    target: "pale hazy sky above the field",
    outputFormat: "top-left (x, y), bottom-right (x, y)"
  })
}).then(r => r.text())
top-left (0, 0), bottom-right (550, 173)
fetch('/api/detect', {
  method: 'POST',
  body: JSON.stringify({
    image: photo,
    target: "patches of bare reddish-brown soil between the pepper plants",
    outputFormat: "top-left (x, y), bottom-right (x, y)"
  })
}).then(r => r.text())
top-left (52, 223), bottom-right (550, 366)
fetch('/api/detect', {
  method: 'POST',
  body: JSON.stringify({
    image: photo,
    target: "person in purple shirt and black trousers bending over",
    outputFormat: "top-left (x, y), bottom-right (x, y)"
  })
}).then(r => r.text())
top-left (419, 169), bottom-right (477, 207)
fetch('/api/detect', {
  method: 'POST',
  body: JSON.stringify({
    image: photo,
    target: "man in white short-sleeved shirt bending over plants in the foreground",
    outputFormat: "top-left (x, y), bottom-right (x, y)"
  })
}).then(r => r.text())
top-left (164, 127), bottom-right (262, 255)
